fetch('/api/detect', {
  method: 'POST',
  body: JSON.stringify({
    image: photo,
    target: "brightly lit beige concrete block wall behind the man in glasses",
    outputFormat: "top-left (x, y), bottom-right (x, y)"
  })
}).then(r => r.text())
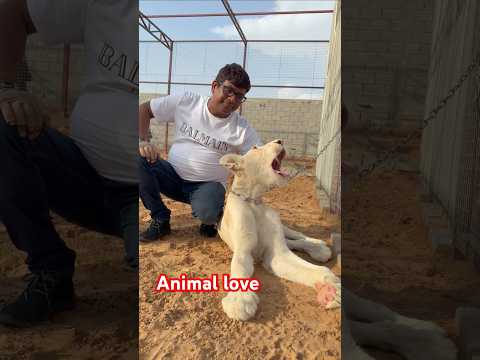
top-left (139, 94), bottom-right (322, 156)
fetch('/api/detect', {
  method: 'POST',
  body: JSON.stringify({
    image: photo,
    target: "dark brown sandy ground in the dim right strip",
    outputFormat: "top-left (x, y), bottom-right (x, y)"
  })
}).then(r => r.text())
top-left (342, 131), bottom-right (480, 359)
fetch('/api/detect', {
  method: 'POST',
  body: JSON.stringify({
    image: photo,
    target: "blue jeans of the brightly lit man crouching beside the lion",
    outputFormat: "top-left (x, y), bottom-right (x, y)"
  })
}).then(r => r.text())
top-left (140, 158), bottom-right (225, 225)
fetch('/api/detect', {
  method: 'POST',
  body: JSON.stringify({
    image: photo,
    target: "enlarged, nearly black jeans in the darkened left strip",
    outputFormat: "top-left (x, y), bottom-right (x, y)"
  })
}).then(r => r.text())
top-left (0, 114), bottom-right (138, 275)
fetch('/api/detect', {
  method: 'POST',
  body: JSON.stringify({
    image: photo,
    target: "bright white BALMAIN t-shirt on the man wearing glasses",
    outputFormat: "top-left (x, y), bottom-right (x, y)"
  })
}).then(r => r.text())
top-left (150, 93), bottom-right (262, 184)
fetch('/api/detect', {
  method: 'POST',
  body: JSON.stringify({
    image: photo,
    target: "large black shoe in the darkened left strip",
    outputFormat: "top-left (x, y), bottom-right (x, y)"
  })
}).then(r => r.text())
top-left (0, 272), bottom-right (75, 327)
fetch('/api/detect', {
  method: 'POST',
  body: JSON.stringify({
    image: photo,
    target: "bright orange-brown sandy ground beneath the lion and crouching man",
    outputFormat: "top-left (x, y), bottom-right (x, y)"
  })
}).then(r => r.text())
top-left (140, 163), bottom-right (340, 360)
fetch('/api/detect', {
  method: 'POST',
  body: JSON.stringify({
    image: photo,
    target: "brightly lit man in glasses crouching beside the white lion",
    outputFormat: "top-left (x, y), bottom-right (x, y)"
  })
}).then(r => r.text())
top-left (139, 64), bottom-right (261, 241)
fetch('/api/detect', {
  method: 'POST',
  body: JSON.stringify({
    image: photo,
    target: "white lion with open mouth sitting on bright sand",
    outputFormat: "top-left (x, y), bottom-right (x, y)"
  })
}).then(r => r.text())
top-left (218, 140), bottom-right (341, 320)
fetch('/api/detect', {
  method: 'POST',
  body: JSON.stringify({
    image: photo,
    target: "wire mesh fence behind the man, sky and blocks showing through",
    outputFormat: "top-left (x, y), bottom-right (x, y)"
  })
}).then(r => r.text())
top-left (139, 41), bottom-right (328, 158)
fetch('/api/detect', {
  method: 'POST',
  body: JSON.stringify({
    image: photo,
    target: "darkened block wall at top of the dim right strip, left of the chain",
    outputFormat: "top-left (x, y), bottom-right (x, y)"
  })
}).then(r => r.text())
top-left (342, 0), bottom-right (433, 130)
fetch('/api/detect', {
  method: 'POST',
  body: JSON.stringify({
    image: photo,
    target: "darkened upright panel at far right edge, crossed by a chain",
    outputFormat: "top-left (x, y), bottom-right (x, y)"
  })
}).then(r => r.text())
top-left (421, 0), bottom-right (480, 256)
